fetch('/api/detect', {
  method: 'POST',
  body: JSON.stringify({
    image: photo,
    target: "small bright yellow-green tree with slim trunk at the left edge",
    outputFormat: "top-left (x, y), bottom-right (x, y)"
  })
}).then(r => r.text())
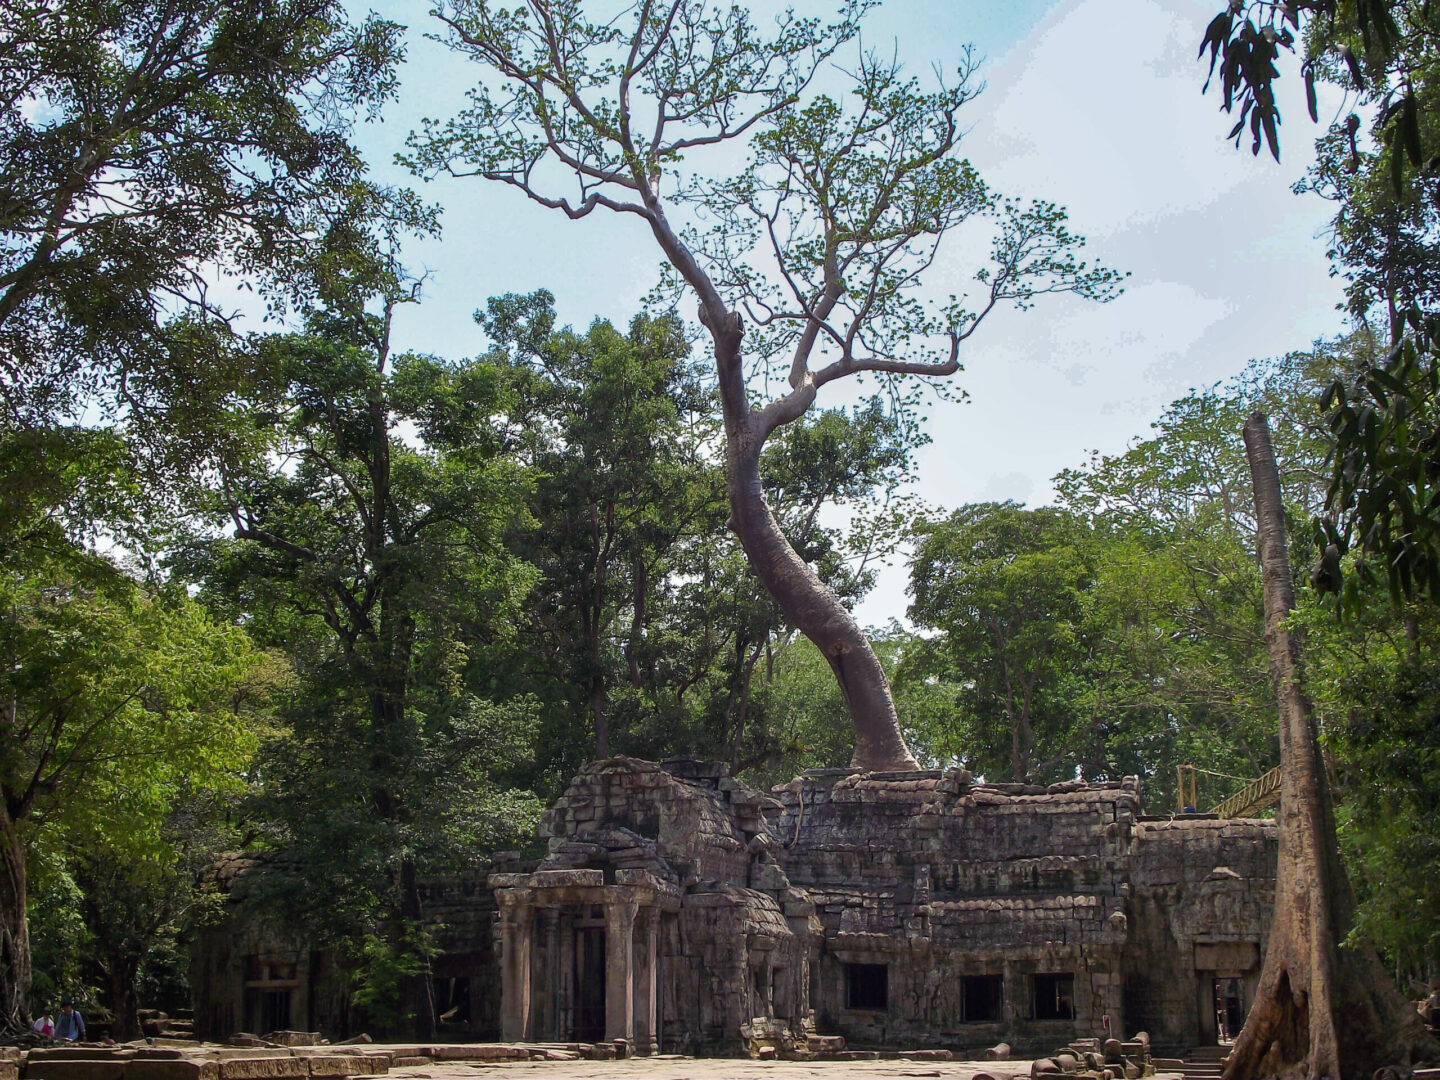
top-left (0, 559), bottom-right (265, 1028)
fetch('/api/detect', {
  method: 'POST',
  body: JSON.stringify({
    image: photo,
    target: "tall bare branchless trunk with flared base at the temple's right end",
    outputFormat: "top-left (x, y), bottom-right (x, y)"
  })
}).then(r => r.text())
top-left (1224, 413), bottom-right (1423, 1080)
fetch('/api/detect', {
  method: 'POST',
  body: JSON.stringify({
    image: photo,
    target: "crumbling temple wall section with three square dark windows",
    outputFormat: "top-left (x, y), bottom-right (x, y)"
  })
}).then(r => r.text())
top-left (773, 770), bottom-right (1139, 1053)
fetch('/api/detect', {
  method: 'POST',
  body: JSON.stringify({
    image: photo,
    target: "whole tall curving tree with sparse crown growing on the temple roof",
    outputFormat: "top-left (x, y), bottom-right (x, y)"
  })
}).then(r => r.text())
top-left (410, 0), bottom-right (1119, 769)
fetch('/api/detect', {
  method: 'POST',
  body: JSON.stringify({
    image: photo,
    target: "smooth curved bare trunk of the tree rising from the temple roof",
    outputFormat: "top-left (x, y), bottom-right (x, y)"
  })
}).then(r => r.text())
top-left (701, 317), bottom-right (919, 772)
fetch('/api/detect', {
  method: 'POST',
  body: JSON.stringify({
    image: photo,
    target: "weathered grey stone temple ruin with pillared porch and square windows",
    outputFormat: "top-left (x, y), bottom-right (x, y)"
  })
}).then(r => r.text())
top-left (196, 757), bottom-right (1277, 1056)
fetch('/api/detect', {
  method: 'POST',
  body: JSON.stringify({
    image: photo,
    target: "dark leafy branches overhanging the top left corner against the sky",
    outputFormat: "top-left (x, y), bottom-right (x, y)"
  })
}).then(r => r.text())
top-left (0, 0), bottom-right (428, 426)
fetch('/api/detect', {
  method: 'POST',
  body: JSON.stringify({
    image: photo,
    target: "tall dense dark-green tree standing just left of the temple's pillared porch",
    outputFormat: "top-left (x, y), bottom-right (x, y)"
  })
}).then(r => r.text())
top-left (174, 301), bottom-right (534, 1034)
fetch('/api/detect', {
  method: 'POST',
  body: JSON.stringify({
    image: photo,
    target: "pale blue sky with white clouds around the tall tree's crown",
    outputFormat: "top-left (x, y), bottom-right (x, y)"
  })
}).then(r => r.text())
top-left (336, 0), bottom-right (1342, 625)
